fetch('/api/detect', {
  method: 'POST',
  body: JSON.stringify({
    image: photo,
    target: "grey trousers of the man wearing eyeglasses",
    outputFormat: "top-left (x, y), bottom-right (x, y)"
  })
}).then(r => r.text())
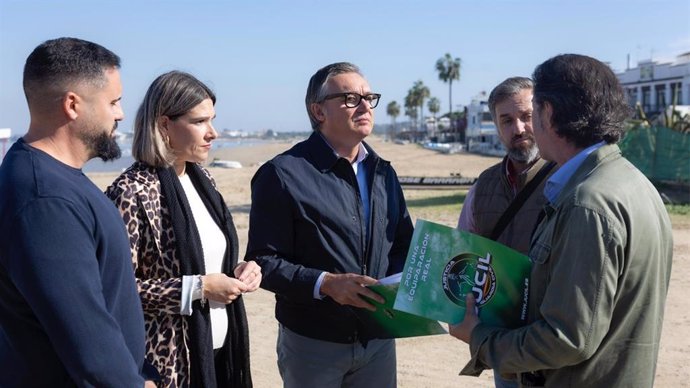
top-left (277, 325), bottom-right (397, 388)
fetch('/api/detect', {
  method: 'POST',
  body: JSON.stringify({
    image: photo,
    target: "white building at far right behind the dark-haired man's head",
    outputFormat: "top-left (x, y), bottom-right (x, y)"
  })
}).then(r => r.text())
top-left (616, 52), bottom-right (690, 115)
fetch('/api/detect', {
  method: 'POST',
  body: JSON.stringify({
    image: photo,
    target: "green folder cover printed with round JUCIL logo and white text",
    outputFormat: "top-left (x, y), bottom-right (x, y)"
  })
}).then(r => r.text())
top-left (394, 220), bottom-right (531, 328)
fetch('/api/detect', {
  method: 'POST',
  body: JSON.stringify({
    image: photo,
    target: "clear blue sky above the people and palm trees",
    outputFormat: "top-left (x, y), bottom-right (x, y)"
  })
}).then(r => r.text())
top-left (0, 0), bottom-right (690, 134)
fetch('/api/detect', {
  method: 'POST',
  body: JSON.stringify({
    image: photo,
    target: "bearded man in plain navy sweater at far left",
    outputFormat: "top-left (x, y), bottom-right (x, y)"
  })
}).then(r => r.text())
top-left (0, 38), bottom-right (155, 387)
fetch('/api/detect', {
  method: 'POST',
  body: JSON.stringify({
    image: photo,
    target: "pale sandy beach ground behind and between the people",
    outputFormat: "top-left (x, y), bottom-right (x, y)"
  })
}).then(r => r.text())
top-left (89, 137), bottom-right (690, 388)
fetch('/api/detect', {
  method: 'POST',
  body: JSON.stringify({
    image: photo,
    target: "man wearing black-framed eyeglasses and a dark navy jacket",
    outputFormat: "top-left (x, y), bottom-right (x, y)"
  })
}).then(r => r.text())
top-left (246, 63), bottom-right (412, 388)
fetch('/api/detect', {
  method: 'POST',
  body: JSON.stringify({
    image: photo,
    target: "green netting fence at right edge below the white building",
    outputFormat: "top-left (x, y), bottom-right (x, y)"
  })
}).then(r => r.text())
top-left (620, 126), bottom-right (690, 183)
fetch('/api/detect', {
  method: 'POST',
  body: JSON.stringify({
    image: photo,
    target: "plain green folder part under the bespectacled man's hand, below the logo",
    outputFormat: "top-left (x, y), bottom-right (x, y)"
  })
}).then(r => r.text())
top-left (354, 283), bottom-right (447, 338)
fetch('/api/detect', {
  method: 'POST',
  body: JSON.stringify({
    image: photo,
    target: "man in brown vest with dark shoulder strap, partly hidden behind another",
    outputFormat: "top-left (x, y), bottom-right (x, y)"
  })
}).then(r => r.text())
top-left (458, 77), bottom-right (555, 388)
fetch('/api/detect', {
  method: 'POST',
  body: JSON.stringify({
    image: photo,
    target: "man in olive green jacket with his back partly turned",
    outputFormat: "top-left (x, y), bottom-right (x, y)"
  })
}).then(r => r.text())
top-left (451, 54), bottom-right (673, 387)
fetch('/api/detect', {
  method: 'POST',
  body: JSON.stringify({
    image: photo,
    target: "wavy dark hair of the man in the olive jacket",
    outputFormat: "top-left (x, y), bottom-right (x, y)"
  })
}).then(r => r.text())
top-left (532, 54), bottom-right (630, 148)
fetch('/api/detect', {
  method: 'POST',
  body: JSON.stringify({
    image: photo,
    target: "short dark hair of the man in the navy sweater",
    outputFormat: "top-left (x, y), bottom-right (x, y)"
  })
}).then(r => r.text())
top-left (24, 38), bottom-right (120, 105)
